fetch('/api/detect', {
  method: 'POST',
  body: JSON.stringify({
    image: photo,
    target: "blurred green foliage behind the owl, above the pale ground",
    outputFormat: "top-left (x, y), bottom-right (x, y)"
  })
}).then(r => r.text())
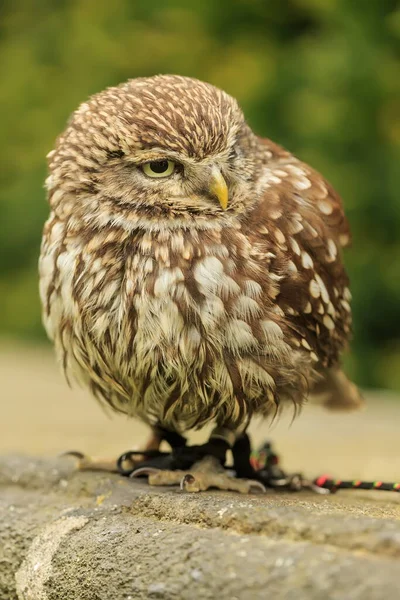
top-left (0, 0), bottom-right (400, 389)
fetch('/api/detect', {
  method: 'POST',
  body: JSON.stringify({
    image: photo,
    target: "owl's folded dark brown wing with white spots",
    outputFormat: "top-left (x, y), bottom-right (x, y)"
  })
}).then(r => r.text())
top-left (247, 146), bottom-right (351, 367)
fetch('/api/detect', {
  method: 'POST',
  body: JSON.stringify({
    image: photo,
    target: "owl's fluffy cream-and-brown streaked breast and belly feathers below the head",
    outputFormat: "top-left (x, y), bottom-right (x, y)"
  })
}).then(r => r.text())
top-left (41, 220), bottom-right (318, 427)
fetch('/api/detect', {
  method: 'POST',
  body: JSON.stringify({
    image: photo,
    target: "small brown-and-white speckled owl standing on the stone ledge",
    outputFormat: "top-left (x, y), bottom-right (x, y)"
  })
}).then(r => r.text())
top-left (39, 75), bottom-right (360, 491)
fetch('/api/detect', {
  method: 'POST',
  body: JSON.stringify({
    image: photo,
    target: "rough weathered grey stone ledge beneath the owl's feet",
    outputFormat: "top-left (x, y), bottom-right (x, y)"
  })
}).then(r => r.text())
top-left (0, 457), bottom-right (400, 600)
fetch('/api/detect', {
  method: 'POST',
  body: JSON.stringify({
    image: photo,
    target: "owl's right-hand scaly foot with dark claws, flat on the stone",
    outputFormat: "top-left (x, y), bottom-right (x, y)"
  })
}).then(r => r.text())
top-left (130, 456), bottom-right (266, 494)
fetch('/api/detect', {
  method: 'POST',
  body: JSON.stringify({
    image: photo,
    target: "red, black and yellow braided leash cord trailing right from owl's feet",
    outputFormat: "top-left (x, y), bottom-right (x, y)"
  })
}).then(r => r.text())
top-left (250, 442), bottom-right (400, 494)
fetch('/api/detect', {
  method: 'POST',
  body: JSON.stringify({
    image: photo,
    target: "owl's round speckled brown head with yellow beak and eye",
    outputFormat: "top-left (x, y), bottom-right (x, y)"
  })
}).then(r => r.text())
top-left (47, 75), bottom-right (266, 224)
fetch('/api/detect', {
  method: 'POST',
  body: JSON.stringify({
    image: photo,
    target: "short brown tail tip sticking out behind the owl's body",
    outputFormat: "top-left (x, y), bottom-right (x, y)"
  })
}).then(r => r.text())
top-left (311, 367), bottom-right (364, 410)
